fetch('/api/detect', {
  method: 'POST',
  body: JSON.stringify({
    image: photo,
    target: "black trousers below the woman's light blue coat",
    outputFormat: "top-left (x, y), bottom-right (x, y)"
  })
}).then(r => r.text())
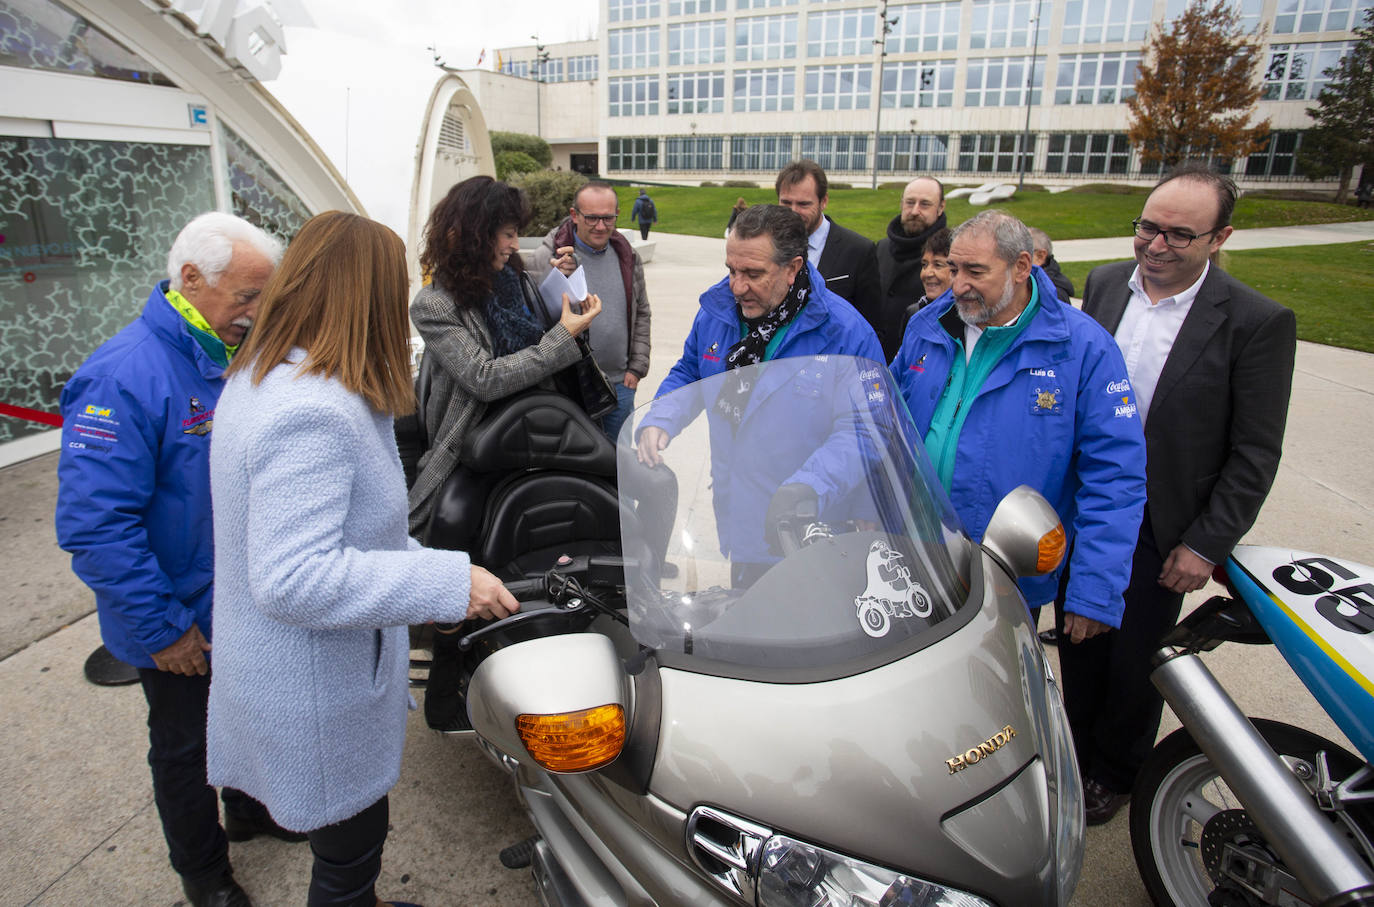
top-left (305, 796), bottom-right (390, 907)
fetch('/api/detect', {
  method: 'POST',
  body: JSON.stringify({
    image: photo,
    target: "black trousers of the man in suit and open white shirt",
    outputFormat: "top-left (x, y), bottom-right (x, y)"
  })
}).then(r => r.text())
top-left (1054, 510), bottom-right (1183, 793)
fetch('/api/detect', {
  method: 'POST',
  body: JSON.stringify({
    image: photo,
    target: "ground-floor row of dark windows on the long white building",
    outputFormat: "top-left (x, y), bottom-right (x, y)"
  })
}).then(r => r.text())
top-left (606, 132), bottom-right (1303, 177)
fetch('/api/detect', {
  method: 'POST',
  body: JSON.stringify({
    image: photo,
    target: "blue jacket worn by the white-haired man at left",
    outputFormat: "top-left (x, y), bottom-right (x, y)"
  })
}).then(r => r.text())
top-left (56, 280), bottom-right (224, 668)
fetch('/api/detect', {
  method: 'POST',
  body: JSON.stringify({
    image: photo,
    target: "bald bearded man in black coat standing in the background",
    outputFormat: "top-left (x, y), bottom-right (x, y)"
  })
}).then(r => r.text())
top-left (874, 176), bottom-right (945, 361)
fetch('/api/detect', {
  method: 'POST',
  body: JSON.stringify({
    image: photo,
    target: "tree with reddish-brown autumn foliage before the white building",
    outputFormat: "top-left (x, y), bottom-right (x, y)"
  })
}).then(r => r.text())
top-left (1127, 0), bottom-right (1270, 168)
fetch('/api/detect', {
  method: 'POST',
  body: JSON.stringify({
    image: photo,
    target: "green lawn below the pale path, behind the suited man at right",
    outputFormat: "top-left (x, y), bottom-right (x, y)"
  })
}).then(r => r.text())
top-left (1059, 240), bottom-right (1374, 353)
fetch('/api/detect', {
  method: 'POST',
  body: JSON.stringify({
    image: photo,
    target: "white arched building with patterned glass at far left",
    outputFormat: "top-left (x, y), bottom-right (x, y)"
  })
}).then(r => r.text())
top-left (0, 0), bottom-right (364, 466)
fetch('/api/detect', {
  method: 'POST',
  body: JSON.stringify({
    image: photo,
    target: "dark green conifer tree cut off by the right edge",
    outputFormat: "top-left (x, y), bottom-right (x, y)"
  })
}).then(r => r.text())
top-left (1297, 10), bottom-right (1374, 205)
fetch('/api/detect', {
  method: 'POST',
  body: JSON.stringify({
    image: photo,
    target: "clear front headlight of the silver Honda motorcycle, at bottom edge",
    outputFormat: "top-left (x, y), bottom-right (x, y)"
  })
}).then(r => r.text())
top-left (758, 830), bottom-right (994, 907)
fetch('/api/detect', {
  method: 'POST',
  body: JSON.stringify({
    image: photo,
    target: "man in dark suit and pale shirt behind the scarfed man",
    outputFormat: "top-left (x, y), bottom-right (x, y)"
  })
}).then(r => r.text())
top-left (774, 159), bottom-right (882, 337)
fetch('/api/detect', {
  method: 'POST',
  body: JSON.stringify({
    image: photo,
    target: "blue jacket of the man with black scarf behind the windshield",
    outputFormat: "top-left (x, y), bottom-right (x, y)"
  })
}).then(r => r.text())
top-left (640, 258), bottom-right (882, 563)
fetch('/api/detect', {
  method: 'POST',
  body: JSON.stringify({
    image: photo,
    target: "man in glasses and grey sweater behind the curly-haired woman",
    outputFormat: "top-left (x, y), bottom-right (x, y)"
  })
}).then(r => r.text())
top-left (530, 181), bottom-right (650, 441)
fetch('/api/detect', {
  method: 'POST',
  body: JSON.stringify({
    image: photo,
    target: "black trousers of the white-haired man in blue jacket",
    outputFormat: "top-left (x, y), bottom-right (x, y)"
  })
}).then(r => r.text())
top-left (139, 668), bottom-right (267, 882)
